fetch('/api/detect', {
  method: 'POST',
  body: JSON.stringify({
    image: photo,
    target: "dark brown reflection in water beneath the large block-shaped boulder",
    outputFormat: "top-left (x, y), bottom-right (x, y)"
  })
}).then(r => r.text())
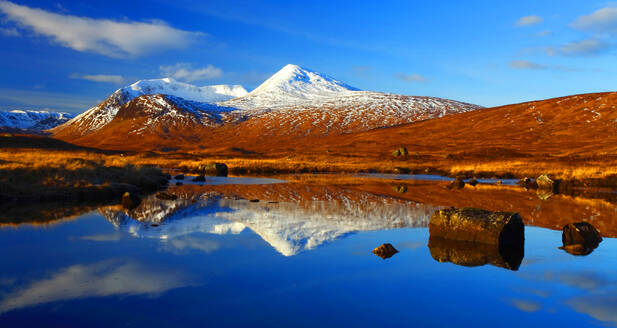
top-left (428, 236), bottom-right (525, 271)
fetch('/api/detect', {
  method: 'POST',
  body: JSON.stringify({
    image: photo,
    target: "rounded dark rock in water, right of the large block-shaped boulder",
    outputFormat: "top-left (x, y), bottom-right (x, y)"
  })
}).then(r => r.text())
top-left (561, 222), bottom-right (602, 255)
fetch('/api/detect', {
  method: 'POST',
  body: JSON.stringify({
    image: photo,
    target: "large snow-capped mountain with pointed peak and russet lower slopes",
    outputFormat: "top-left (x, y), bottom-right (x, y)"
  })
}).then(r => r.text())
top-left (53, 65), bottom-right (479, 150)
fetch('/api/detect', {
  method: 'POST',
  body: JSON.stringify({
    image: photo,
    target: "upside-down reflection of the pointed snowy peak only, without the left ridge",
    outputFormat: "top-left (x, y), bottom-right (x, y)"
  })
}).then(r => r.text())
top-left (217, 198), bottom-right (436, 256)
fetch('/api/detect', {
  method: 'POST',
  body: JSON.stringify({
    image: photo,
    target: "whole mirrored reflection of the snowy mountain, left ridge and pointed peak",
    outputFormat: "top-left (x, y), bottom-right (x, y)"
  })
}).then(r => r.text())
top-left (101, 193), bottom-right (438, 256)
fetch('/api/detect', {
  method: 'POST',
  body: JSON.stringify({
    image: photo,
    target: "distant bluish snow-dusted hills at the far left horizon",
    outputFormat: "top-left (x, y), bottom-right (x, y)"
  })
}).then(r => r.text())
top-left (0, 110), bottom-right (75, 131)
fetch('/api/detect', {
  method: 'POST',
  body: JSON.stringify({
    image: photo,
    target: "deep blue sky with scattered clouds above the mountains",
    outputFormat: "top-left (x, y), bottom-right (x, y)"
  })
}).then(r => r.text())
top-left (0, 0), bottom-right (617, 112)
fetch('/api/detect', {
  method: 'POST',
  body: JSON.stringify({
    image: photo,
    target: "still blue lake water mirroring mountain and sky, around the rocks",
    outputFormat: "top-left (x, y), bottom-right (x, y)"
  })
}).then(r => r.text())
top-left (0, 179), bottom-right (617, 327)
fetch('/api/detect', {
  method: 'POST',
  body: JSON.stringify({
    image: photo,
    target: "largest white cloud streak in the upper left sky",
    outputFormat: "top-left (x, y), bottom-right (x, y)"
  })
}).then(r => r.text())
top-left (0, 0), bottom-right (201, 57)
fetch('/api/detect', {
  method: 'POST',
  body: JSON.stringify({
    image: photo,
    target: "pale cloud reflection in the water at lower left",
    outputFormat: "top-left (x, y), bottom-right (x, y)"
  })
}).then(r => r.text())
top-left (0, 260), bottom-right (193, 313)
